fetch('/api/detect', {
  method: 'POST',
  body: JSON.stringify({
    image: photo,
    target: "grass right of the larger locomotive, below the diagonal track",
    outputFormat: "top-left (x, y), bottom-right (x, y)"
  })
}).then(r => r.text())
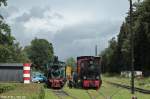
top-left (97, 82), bottom-right (150, 99)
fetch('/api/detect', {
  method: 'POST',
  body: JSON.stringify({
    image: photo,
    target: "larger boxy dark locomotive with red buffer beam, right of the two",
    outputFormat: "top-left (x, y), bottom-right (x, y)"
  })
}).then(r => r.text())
top-left (73, 56), bottom-right (102, 89)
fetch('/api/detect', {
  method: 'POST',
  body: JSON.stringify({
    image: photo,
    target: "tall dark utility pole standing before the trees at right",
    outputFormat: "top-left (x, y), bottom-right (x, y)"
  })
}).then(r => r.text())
top-left (130, 0), bottom-right (135, 94)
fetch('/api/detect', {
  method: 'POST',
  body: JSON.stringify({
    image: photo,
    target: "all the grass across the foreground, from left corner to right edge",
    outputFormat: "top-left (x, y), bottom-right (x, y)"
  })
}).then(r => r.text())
top-left (0, 77), bottom-right (150, 99)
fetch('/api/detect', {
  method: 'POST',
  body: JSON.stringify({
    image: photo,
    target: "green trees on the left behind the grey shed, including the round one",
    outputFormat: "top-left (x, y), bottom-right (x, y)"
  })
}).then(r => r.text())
top-left (0, 0), bottom-right (54, 71)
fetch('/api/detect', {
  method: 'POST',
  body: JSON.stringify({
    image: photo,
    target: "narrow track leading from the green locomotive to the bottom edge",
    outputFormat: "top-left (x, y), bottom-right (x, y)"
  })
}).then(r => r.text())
top-left (52, 89), bottom-right (78, 99)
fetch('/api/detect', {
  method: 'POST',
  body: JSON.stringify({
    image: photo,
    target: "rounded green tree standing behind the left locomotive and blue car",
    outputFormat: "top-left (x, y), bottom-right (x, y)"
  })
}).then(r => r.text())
top-left (25, 38), bottom-right (54, 70)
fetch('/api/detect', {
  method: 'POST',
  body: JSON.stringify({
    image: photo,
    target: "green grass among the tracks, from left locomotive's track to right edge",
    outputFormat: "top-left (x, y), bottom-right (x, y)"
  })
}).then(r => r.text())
top-left (45, 78), bottom-right (150, 99)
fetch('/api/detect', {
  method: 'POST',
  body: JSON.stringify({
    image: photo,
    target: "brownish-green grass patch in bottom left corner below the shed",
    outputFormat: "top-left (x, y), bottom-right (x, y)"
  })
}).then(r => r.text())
top-left (0, 83), bottom-right (45, 99)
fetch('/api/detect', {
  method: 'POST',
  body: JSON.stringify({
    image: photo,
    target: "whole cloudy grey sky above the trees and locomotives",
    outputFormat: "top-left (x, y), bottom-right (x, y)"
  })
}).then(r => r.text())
top-left (0, 0), bottom-right (129, 60)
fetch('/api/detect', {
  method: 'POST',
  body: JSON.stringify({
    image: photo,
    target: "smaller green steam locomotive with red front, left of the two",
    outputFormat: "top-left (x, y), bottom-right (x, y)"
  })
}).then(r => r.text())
top-left (47, 57), bottom-right (66, 88)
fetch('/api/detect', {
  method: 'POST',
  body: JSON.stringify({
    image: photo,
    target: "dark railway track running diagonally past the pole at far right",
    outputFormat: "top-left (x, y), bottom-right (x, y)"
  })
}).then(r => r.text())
top-left (105, 81), bottom-right (150, 94)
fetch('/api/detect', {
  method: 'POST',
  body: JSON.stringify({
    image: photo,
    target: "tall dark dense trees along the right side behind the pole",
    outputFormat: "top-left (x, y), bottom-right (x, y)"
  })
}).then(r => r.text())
top-left (101, 0), bottom-right (150, 75)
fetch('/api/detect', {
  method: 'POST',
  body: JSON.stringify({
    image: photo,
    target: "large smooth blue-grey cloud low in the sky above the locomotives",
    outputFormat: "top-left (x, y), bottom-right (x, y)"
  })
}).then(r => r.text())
top-left (53, 20), bottom-right (121, 59)
